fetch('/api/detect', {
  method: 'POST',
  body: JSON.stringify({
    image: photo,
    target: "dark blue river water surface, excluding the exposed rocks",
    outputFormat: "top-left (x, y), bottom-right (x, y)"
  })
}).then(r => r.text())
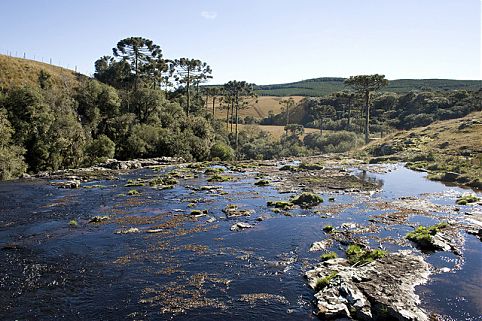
top-left (0, 167), bottom-right (482, 320)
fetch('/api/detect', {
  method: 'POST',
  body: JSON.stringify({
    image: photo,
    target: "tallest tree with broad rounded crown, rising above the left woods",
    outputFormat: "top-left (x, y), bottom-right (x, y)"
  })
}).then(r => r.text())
top-left (112, 37), bottom-right (167, 90)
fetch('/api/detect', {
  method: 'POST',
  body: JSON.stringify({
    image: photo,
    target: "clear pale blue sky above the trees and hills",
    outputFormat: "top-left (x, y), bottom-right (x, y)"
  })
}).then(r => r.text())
top-left (0, 0), bottom-right (482, 85)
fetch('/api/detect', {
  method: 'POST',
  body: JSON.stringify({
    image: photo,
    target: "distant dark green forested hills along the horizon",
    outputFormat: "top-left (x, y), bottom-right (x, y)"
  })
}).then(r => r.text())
top-left (257, 78), bottom-right (482, 97)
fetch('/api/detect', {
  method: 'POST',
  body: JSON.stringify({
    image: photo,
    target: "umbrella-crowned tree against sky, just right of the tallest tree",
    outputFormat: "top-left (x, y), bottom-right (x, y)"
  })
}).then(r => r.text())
top-left (173, 58), bottom-right (212, 116)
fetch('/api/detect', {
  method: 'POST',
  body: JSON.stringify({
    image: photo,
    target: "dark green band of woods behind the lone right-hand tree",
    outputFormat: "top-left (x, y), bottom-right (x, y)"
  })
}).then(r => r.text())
top-left (261, 89), bottom-right (482, 133)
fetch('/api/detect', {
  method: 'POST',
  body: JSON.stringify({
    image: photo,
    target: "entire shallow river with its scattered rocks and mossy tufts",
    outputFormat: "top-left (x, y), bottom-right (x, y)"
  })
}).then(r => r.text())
top-left (0, 156), bottom-right (482, 320)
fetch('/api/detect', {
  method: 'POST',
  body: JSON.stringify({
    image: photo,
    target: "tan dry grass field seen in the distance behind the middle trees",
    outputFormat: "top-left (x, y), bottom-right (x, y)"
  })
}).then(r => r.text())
top-left (208, 96), bottom-right (304, 119)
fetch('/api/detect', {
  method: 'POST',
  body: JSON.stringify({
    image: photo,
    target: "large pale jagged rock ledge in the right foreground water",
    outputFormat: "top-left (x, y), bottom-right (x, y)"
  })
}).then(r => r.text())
top-left (305, 251), bottom-right (430, 321)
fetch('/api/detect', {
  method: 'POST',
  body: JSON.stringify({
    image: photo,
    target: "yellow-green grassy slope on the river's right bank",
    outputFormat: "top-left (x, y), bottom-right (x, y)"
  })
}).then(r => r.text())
top-left (363, 112), bottom-right (482, 189)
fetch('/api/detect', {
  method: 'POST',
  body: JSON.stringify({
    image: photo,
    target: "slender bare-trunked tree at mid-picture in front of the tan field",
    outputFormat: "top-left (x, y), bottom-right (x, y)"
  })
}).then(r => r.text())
top-left (224, 80), bottom-right (257, 159)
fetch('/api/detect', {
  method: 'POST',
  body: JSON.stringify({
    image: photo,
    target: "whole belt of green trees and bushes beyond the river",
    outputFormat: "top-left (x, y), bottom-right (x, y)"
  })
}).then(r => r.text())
top-left (0, 37), bottom-right (482, 179)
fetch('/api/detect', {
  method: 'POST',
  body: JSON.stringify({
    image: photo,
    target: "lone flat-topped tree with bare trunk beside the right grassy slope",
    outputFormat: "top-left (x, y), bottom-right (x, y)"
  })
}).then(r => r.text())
top-left (345, 74), bottom-right (388, 144)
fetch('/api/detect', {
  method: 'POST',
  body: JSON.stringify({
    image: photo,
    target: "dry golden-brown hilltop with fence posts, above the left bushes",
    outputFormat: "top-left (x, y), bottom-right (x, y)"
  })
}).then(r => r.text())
top-left (0, 55), bottom-right (85, 91)
